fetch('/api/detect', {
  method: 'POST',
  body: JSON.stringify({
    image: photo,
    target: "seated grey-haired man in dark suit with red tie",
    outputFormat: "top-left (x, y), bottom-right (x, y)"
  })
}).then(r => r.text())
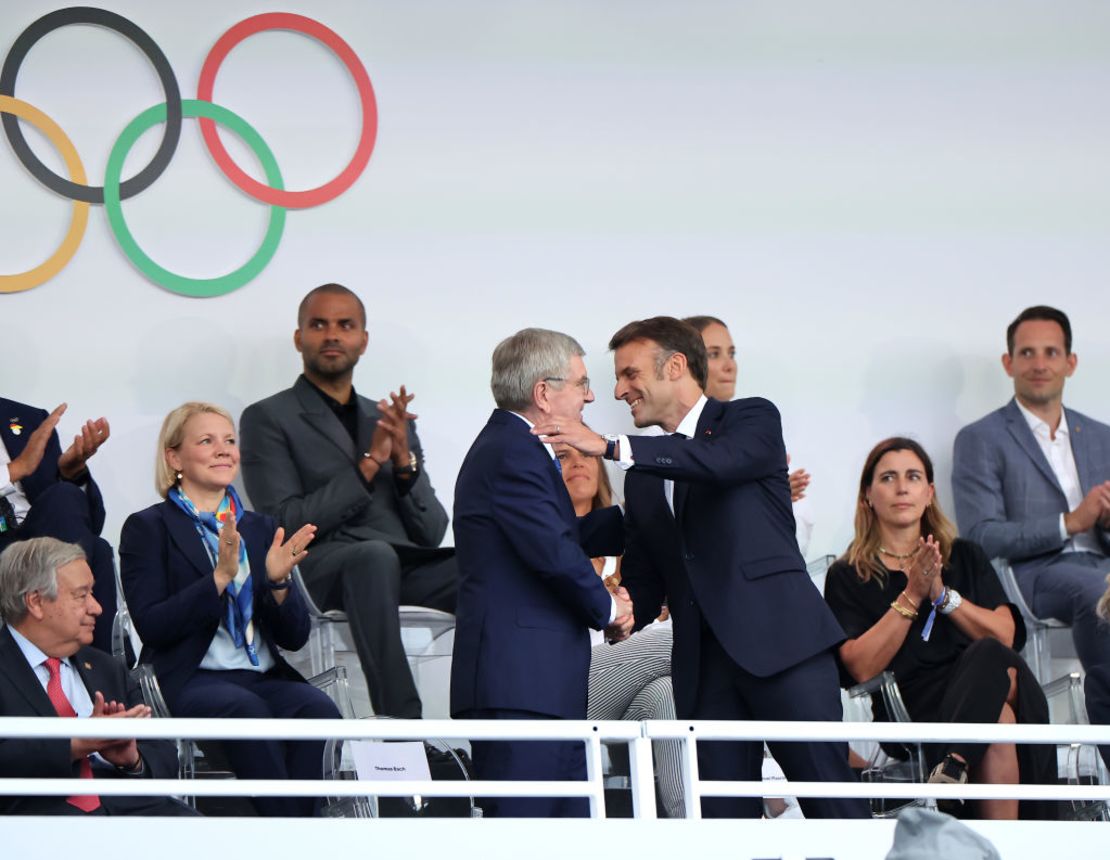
top-left (0, 537), bottom-right (187, 816)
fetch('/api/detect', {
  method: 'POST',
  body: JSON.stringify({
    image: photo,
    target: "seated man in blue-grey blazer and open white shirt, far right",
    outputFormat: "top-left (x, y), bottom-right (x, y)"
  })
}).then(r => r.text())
top-left (952, 306), bottom-right (1110, 757)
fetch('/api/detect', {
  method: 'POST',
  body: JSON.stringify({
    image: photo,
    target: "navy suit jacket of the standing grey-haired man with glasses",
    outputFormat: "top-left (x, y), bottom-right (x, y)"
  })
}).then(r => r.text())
top-left (451, 409), bottom-right (620, 719)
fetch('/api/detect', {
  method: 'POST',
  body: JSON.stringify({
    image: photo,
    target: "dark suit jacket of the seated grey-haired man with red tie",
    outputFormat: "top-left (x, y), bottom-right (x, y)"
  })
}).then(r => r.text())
top-left (0, 627), bottom-right (178, 815)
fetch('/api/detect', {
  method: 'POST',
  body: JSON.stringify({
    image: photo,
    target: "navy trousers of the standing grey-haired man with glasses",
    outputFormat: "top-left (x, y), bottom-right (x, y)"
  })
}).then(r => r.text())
top-left (460, 709), bottom-right (589, 818)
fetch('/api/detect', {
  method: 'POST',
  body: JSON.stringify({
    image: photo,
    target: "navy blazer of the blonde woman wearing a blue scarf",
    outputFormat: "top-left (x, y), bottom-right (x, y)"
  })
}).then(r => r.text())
top-left (120, 502), bottom-right (310, 711)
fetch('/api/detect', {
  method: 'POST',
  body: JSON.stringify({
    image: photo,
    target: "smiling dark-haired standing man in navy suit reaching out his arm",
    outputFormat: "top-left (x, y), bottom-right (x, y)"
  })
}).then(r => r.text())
top-left (533, 316), bottom-right (870, 818)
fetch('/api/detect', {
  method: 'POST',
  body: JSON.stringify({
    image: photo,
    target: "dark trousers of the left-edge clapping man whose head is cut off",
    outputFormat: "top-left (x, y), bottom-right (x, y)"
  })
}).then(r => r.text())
top-left (0, 480), bottom-right (117, 654)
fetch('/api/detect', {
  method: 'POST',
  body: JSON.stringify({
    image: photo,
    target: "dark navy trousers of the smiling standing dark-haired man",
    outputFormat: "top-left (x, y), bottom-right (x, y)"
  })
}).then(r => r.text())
top-left (678, 624), bottom-right (871, 818)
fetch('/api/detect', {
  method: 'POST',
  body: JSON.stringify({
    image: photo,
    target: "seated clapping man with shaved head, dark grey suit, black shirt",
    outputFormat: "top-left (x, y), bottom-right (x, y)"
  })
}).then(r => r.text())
top-left (240, 284), bottom-right (458, 719)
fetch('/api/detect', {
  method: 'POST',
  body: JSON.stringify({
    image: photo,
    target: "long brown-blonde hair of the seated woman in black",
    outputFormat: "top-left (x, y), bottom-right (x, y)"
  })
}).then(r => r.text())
top-left (844, 436), bottom-right (956, 583)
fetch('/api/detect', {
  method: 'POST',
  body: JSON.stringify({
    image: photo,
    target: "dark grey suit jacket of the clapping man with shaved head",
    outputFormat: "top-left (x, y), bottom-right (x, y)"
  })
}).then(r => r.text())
top-left (240, 376), bottom-right (447, 552)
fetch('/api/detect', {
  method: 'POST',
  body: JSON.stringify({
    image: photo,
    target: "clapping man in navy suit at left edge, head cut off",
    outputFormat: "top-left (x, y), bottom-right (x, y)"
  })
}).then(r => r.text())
top-left (0, 397), bottom-right (115, 651)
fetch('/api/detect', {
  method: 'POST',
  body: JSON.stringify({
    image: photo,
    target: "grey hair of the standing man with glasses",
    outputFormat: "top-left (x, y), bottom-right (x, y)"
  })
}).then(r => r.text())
top-left (490, 328), bottom-right (586, 412)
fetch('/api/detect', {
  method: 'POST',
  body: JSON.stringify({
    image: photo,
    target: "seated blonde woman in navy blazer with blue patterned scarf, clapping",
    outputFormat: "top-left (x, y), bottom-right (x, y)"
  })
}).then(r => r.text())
top-left (120, 403), bottom-right (340, 816)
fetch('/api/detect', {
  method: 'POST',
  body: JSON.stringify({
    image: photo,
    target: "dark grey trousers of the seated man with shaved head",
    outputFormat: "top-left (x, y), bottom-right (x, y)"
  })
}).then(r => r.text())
top-left (303, 540), bottom-right (458, 719)
